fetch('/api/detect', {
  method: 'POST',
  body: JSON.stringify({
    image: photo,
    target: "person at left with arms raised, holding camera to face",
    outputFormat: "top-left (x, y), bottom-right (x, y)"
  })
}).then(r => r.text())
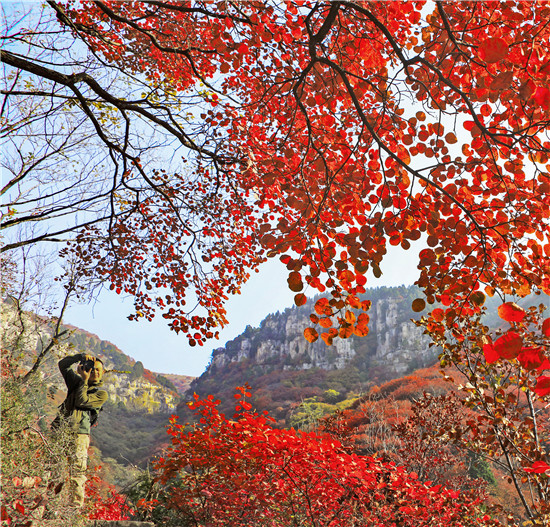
top-left (52, 354), bottom-right (107, 507)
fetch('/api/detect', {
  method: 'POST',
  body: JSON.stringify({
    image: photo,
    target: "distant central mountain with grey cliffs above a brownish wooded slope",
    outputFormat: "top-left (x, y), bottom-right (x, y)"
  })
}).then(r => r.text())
top-left (185, 286), bottom-right (549, 426)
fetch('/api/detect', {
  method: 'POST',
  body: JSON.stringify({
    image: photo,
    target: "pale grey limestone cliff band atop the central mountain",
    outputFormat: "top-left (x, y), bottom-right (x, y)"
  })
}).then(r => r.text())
top-left (201, 288), bottom-right (436, 375)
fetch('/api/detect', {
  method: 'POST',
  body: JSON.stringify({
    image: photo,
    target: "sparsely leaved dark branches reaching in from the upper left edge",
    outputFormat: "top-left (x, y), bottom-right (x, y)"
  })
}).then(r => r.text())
top-left (0, 2), bottom-right (263, 344)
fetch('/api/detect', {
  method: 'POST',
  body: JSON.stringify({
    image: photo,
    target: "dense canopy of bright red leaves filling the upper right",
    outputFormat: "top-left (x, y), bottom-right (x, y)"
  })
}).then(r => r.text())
top-left (57, 0), bottom-right (550, 343)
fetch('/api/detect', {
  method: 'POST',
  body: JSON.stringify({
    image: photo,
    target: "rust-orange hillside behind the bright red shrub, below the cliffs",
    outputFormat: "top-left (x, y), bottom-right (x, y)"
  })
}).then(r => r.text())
top-left (316, 366), bottom-right (550, 514)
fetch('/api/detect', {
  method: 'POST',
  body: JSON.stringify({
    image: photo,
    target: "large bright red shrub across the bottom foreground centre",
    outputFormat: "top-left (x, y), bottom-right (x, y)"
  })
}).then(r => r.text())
top-left (152, 387), bottom-right (499, 527)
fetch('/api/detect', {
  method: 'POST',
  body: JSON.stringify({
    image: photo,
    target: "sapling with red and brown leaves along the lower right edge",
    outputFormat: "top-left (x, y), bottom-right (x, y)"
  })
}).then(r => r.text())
top-left (419, 302), bottom-right (550, 525)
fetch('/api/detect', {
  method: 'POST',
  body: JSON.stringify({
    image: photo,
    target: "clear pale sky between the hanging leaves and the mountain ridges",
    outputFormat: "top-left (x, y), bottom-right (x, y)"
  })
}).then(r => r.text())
top-left (65, 245), bottom-right (422, 376)
